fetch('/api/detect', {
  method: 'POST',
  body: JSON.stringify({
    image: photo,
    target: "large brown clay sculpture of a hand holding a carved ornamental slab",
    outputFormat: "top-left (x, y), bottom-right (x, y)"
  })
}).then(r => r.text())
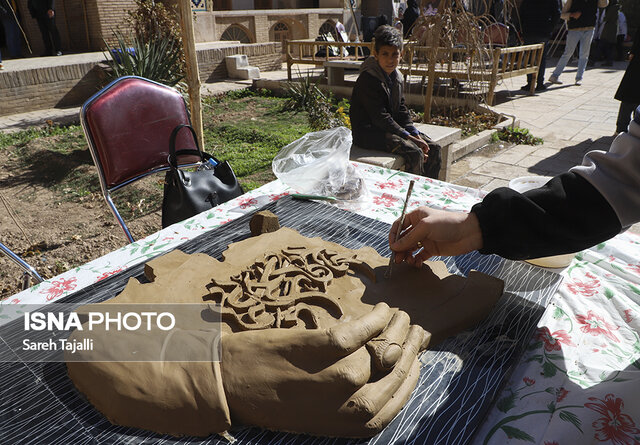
top-left (67, 228), bottom-right (503, 437)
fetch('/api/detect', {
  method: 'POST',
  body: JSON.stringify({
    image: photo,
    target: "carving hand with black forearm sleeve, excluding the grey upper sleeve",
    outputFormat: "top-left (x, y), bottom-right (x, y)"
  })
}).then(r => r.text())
top-left (390, 172), bottom-right (620, 265)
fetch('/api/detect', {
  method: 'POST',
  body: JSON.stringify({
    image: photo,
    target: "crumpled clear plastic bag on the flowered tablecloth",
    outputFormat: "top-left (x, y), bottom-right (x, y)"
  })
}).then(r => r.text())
top-left (272, 127), bottom-right (368, 201)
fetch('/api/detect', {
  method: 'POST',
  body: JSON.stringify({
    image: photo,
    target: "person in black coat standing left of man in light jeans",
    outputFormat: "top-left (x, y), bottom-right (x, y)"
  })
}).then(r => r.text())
top-left (520, 0), bottom-right (560, 91)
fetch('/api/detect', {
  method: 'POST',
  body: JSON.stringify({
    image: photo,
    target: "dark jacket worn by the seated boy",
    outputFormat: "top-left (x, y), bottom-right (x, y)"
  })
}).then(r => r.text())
top-left (349, 56), bottom-right (418, 149)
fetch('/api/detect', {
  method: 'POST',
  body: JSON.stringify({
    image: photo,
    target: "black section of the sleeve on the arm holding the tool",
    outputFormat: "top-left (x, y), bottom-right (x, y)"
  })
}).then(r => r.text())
top-left (471, 172), bottom-right (622, 260)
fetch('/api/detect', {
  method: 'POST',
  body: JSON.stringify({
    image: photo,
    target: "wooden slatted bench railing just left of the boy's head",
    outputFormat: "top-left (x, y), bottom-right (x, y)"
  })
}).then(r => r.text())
top-left (286, 40), bottom-right (373, 80)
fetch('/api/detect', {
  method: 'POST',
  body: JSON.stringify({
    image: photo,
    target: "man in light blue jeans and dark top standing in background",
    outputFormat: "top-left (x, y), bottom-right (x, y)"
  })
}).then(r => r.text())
top-left (549, 0), bottom-right (609, 85)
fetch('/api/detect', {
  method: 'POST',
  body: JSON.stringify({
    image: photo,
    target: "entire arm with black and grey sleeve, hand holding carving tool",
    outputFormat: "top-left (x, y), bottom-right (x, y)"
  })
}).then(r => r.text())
top-left (389, 117), bottom-right (640, 263)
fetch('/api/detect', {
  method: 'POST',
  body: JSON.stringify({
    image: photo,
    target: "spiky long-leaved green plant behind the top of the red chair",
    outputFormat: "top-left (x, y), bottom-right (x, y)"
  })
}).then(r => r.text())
top-left (105, 31), bottom-right (184, 86)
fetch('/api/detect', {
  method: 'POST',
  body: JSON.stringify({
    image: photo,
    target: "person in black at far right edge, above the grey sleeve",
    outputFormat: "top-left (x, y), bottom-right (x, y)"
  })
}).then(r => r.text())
top-left (614, 28), bottom-right (640, 134)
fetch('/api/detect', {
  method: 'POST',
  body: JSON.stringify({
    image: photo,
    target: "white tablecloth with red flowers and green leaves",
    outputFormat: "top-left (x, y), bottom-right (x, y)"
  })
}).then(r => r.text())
top-left (2, 163), bottom-right (640, 445)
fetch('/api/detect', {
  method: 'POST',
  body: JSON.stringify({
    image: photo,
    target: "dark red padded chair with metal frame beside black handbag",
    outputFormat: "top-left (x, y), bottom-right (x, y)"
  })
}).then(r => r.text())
top-left (80, 76), bottom-right (199, 242)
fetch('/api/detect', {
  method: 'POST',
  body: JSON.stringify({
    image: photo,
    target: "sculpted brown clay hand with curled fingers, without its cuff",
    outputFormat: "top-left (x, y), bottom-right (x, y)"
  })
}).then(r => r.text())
top-left (221, 303), bottom-right (426, 437)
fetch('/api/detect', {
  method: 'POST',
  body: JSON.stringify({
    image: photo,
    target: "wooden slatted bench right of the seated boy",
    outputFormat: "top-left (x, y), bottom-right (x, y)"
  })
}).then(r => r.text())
top-left (400, 43), bottom-right (544, 119)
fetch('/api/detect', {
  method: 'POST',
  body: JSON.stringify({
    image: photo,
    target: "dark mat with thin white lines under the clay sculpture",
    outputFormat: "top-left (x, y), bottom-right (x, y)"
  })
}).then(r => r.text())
top-left (0, 198), bottom-right (561, 445)
